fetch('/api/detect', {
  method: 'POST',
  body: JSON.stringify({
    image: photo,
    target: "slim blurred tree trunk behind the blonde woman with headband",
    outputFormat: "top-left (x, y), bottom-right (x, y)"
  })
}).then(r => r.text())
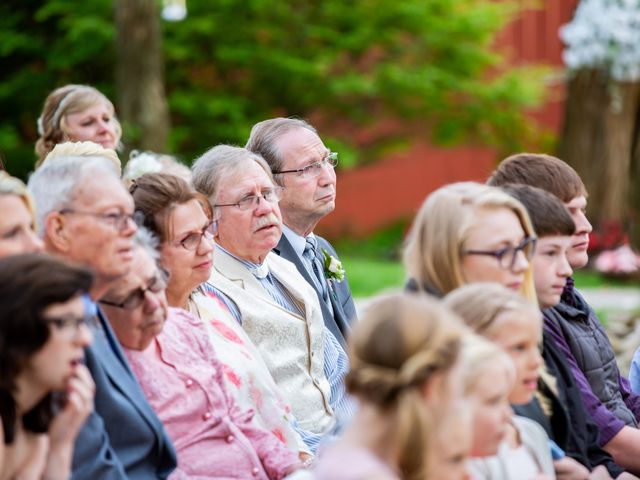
top-left (115, 0), bottom-right (169, 156)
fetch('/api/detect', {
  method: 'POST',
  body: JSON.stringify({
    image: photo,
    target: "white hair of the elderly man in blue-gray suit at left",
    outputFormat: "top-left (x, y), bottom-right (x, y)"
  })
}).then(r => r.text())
top-left (27, 156), bottom-right (120, 236)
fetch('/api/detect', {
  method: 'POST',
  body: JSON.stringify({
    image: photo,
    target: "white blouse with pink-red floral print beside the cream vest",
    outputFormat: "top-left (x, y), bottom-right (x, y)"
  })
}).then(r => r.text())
top-left (191, 289), bottom-right (308, 451)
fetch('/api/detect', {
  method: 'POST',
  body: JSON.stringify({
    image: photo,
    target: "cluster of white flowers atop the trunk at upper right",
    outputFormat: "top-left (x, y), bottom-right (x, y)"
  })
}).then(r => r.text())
top-left (560, 0), bottom-right (640, 81)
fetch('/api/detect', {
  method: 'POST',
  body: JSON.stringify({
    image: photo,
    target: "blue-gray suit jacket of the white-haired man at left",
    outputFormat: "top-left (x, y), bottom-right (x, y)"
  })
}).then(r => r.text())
top-left (72, 312), bottom-right (176, 480)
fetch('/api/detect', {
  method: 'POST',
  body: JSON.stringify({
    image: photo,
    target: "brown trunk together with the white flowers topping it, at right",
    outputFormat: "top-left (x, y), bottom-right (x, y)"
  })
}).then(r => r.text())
top-left (559, 0), bottom-right (640, 244)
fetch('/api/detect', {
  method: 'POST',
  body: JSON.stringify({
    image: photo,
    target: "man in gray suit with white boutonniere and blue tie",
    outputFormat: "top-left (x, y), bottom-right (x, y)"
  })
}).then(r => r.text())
top-left (246, 118), bottom-right (356, 345)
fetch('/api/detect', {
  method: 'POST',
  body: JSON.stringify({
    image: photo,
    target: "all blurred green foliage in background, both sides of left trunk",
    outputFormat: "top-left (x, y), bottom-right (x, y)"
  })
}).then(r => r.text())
top-left (0, 0), bottom-right (543, 180)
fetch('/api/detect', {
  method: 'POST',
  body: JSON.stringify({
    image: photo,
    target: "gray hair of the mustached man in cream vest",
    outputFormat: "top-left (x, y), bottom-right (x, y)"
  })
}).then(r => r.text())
top-left (191, 145), bottom-right (275, 208)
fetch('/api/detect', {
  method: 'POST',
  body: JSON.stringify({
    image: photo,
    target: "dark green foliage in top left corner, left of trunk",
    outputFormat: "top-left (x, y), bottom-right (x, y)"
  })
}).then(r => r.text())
top-left (0, 0), bottom-right (115, 178)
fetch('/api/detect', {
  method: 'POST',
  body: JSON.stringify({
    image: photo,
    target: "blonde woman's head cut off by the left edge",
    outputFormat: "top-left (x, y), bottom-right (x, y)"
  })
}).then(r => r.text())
top-left (0, 171), bottom-right (44, 258)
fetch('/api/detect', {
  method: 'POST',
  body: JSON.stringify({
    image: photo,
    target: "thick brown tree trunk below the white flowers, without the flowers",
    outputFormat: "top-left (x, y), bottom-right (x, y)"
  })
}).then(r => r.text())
top-left (559, 70), bottom-right (640, 226)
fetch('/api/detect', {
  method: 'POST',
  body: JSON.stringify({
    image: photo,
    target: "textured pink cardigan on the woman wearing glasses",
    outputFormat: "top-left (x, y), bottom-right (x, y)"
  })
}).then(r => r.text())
top-left (125, 308), bottom-right (298, 480)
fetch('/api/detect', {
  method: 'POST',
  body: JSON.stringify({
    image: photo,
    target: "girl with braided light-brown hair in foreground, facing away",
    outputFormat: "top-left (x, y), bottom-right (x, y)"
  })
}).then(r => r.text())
top-left (315, 294), bottom-right (466, 480)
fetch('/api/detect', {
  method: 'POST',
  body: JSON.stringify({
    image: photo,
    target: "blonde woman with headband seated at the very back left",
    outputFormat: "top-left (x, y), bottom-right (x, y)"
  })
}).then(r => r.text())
top-left (35, 85), bottom-right (122, 167)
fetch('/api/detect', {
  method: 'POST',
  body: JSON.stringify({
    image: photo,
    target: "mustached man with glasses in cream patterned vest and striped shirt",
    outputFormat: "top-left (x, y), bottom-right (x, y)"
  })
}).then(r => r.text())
top-left (193, 145), bottom-right (354, 450)
